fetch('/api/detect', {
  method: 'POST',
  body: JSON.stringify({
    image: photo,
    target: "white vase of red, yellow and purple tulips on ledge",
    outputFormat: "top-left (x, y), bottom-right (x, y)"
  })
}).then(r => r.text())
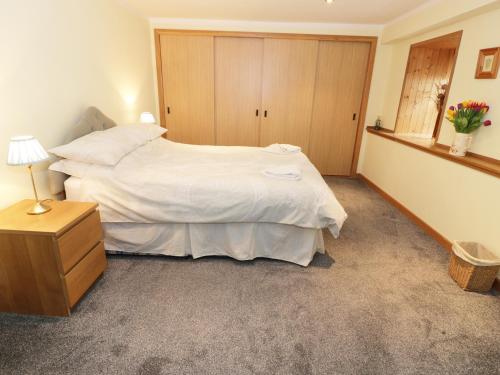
top-left (446, 100), bottom-right (491, 156)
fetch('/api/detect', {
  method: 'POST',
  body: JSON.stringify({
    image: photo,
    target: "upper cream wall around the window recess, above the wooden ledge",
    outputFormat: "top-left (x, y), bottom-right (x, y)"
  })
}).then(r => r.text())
top-left (382, 9), bottom-right (500, 159)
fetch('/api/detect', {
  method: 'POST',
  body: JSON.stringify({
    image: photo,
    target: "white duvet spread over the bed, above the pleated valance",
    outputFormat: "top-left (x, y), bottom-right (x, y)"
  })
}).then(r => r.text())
top-left (76, 138), bottom-right (347, 237)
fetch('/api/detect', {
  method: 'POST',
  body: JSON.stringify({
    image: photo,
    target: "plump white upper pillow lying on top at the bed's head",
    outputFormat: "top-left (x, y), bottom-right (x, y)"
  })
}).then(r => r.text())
top-left (49, 124), bottom-right (167, 166)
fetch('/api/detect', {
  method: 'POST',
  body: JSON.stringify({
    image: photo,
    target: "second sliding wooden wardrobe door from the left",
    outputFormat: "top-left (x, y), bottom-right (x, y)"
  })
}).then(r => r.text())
top-left (215, 37), bottom-right (264, 146)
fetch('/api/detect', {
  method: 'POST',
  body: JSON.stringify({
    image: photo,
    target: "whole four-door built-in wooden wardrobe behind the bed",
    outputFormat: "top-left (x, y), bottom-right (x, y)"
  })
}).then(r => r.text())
top-left (155, 30), bottom-right (376, 176)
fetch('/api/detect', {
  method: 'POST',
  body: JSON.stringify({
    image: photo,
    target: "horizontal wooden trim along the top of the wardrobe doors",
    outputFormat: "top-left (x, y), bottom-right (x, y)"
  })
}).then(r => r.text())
top-left (154, 29), bottom-right (378, 43)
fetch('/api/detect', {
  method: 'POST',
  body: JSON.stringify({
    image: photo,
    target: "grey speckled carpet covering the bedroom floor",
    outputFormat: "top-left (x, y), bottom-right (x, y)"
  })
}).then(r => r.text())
top-left (0, 178), bottom-right (500, 375)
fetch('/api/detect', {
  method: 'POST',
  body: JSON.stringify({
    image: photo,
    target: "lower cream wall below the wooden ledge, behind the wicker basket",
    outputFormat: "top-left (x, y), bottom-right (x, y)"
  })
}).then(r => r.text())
top-left (361, 134), bottom-right (500, 256)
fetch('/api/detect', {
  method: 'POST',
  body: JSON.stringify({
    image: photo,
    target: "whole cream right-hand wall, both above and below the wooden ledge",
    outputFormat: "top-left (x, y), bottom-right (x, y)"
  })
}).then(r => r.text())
top-left (360, 8), bottom-right (500, 262)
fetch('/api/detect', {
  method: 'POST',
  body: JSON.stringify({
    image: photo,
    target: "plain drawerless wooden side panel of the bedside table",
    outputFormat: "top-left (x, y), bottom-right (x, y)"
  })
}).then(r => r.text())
top-left (0, 233), bottom-right (69, 316)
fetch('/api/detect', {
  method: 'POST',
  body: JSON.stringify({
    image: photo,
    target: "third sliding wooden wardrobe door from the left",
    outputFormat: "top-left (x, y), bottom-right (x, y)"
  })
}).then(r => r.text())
top-left (260, 39), bottom-right (319, 152)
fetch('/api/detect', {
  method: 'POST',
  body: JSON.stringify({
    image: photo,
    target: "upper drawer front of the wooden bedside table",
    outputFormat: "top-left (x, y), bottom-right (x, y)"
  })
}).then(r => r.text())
top-left (57, 211), bottom-right (102, 274)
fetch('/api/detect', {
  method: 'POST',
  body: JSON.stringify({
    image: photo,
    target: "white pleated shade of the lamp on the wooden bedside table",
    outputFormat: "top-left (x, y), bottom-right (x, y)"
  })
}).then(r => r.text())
top-left (7, 135), bottom-right (49, 165)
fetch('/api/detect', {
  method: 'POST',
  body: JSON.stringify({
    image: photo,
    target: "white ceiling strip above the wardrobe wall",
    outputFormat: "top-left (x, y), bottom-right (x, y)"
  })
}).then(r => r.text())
top-left (119, 0), bottom-right (433, 24)
